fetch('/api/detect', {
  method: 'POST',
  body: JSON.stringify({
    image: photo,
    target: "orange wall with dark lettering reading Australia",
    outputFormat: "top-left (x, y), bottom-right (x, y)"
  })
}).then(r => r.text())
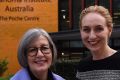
top-left (0, 0), bottom-right (58, 73)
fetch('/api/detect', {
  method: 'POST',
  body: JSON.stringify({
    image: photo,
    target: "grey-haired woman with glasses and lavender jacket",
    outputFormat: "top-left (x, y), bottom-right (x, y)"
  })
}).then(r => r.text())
top-left (10, 28), bottom-right (65, 80)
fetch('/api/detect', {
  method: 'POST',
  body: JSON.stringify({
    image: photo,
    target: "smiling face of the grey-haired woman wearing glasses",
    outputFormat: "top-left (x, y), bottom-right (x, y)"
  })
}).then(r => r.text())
top-left (27, 36), bottom-right (52, 73)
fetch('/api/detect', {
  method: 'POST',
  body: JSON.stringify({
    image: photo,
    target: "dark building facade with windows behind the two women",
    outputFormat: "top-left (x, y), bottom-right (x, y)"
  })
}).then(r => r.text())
top-left (50, 0), bottom-right (120, 80)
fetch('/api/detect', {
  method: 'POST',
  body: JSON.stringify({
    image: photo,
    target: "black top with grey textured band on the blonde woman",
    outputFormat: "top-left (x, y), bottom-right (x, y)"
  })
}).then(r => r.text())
top-left (76, 51), bottom-right (120, 80)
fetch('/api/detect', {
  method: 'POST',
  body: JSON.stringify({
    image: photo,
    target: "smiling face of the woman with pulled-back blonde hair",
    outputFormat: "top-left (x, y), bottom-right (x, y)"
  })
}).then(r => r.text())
top-left (80, 13), bottom-right (112, 52)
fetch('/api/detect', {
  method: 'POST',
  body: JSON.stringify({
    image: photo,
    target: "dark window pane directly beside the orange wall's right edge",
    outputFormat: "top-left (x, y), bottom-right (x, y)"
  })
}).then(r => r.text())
top-left (59, 0), bottom-right (69, 31)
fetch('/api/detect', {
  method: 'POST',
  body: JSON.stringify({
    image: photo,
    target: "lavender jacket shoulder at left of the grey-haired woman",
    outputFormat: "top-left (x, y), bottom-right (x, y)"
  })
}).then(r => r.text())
top-left (10, 68), bottom-right (31, 80)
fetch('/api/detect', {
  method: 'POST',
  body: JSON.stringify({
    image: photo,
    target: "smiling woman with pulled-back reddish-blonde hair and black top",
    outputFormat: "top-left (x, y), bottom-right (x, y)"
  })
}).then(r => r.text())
top-left (76, 5), bottom-right (120, 80)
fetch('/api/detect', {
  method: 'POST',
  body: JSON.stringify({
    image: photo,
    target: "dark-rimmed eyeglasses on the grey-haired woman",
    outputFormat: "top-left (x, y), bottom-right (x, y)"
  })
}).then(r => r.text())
top-left (27, 46), bottom-right (51, 57)
